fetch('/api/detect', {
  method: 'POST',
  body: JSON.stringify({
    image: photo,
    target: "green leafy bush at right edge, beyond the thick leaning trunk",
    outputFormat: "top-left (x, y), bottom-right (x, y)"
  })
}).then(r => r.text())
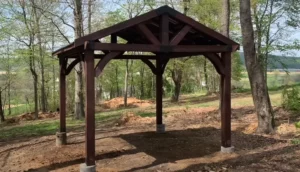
top-left (282, 87), bottom-right (300, 111)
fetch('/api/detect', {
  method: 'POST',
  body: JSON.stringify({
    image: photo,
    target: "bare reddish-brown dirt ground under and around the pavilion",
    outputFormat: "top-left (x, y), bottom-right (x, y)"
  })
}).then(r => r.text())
top-left (0, 107), bottom-right (300, 172)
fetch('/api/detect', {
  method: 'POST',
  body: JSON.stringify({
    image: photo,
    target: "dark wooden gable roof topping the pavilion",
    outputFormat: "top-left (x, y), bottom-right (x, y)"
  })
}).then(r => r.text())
top-left (54, 6), bottom-right (239, 54)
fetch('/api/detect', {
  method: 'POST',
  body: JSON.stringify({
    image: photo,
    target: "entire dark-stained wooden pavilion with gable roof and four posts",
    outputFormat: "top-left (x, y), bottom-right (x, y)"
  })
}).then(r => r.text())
top-left (53, 6), bottom-right (239, 171)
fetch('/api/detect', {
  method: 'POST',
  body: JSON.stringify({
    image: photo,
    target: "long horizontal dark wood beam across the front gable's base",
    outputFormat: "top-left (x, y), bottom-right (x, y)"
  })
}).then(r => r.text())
top-left (90, 43), bottom-right (232, 53)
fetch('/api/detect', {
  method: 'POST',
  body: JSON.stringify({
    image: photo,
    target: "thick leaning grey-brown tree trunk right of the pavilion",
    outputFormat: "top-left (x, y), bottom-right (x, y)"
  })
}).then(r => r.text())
top-left (240, 0), bottom-right (273, 134)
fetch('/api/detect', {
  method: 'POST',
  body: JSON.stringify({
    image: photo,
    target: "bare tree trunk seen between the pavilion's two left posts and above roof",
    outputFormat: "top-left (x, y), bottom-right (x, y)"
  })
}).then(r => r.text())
top-left (74, 0), bottom-right (84, 119)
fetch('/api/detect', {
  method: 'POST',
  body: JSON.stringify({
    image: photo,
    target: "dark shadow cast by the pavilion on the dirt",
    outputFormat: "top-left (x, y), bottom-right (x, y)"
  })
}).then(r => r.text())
top-left (25, 127), bottom-right (282, 171)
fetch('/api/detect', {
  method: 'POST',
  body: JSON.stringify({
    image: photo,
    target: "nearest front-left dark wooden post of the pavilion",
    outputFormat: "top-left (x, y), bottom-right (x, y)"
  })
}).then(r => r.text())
top-left (84, 44), bottom-right (95, 167)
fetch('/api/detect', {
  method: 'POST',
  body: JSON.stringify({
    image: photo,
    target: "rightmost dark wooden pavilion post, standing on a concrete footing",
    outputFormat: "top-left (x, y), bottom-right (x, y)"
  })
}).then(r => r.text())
top-left (221, 52), bottom-right (231, 152)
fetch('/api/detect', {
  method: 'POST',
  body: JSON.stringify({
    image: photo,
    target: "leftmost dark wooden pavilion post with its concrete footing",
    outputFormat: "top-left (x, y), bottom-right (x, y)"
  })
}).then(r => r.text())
top-left (56, 57), bottom-right (67, 146)
